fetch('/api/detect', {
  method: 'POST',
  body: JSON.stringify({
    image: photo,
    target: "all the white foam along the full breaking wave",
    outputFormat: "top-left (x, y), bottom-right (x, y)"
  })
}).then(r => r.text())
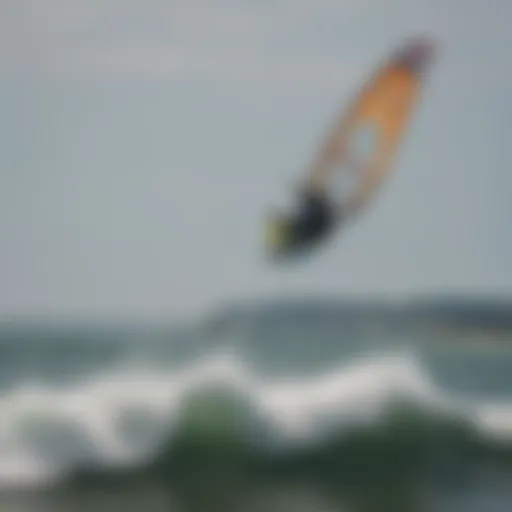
top-left (0, 352), bottom-right (512, 486)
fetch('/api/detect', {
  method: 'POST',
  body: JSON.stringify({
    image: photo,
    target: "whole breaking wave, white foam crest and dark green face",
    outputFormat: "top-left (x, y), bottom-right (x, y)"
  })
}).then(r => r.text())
top-left (0, 350), bottom-right (512, 488)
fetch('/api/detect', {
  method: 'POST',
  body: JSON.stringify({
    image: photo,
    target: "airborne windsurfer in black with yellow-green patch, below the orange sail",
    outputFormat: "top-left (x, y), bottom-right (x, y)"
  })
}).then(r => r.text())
top-left (264, 190), bottom-right (339, 255)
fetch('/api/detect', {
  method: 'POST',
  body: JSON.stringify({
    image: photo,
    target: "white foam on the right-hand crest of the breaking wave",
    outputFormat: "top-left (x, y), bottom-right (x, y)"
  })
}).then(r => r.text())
top-left (260, 356), bottom-right (443, 437)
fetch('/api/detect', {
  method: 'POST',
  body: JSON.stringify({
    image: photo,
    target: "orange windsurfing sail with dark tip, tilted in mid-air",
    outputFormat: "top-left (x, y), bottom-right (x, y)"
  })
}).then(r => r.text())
top-left (306, 39), bottom-right (434, 215)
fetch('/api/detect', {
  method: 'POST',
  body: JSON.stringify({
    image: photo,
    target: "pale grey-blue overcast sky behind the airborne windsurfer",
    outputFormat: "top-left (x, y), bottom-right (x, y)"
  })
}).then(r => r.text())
top-left (0, 0), bottom-right (512, 317)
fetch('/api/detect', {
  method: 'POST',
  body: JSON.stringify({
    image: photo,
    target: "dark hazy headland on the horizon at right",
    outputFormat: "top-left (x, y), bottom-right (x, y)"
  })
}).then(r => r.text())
top-left (203, 296), bottom-right (512, 342)
